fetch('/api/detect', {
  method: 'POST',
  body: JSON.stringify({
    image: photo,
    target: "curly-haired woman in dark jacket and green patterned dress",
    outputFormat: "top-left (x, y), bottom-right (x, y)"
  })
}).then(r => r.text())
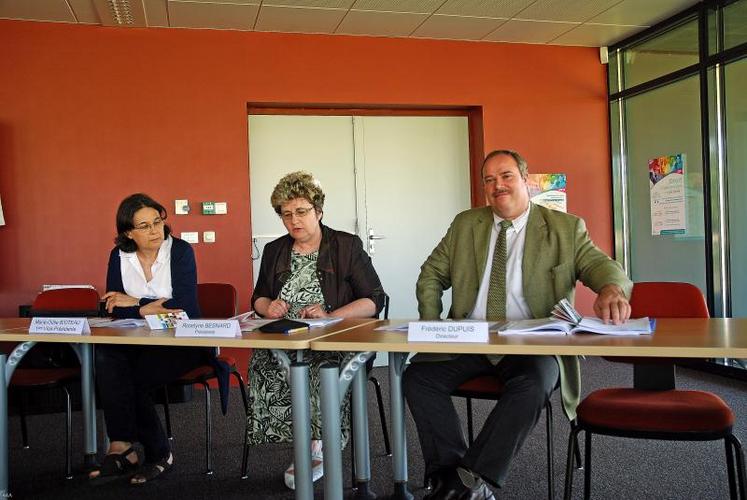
top-left (247, 172), bottom-right (386, 489)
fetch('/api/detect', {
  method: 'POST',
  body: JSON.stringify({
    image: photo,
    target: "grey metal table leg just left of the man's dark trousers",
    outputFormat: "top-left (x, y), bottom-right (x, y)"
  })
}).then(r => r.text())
top-left (389, 352), bottom-right (413, 500)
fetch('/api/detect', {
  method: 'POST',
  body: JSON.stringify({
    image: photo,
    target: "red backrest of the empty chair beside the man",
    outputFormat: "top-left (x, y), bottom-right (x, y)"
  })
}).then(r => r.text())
top-left (630, 281), bottom-right (710, 318)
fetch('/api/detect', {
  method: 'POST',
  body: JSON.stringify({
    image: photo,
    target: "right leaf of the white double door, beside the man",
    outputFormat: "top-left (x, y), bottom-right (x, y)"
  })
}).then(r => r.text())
top-left (355, 116), bottom-right (470, 319)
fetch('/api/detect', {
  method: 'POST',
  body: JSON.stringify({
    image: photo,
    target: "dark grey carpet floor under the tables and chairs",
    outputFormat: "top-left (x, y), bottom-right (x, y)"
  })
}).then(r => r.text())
top-left (9, 358), bottom-right (747, 500)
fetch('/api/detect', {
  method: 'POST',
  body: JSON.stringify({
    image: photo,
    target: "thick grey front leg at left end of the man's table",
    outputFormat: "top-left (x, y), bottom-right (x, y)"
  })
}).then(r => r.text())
top-left (319, 363), bottom-right (342, 500)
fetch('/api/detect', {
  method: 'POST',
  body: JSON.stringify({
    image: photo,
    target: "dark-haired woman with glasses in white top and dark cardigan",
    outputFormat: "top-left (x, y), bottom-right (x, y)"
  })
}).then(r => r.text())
top-left (89, 193), bottom-right (215, 484)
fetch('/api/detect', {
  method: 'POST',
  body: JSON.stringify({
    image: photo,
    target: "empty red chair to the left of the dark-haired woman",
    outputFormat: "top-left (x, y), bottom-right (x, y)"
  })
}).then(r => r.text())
top-left (18, 288), bottom-right (100, 479)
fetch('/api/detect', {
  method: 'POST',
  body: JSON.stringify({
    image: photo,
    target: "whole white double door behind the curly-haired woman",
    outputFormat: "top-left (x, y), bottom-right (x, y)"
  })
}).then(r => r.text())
top-left (249, 115), bottom-right (470, 319)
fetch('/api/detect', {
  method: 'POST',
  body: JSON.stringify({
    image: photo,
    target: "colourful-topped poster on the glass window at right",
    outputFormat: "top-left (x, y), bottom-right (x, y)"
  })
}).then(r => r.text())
top-left (648, 153), bottom-right (687, 236)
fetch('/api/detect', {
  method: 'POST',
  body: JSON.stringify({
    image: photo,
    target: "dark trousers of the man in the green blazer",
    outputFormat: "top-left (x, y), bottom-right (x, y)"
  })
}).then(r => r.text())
top-left (403, 354), bottom-right (560, 487)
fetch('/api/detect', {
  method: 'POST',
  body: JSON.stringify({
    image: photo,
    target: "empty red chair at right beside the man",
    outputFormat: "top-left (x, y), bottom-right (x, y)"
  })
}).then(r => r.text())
top-left (565, 282), bottom-right (745, 500)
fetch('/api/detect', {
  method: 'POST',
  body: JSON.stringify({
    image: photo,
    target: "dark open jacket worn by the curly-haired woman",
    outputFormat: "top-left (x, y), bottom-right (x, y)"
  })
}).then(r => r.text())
top-left (252, 224), bottom-right (386, 315)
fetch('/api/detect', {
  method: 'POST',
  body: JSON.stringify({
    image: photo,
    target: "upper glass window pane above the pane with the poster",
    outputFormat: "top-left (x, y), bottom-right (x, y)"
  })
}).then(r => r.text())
top-left (623, 18), bottom-right (699, 88)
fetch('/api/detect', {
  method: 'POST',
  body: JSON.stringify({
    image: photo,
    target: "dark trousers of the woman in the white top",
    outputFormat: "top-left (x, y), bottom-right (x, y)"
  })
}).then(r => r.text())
top-left (96, 345), bottom-right (213, 462)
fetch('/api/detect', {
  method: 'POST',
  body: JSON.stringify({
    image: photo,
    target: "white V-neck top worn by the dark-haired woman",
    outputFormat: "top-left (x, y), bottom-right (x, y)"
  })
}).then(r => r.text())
top-left (119, 236), bottom-right (173, 299)
